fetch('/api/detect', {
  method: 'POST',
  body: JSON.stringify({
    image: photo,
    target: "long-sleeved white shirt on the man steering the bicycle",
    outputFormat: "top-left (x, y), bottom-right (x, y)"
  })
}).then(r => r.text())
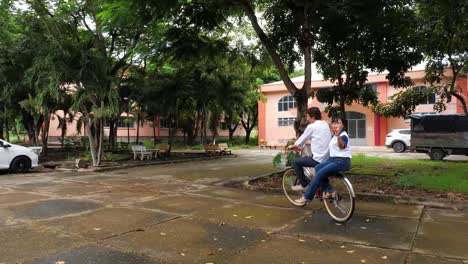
top-left (294, 120), bottom-right (332, 163)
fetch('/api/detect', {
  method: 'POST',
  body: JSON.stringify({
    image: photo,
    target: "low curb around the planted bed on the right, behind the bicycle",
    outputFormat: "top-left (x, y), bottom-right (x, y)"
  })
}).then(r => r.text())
top-left (240, 173), bottom-right (468, 210)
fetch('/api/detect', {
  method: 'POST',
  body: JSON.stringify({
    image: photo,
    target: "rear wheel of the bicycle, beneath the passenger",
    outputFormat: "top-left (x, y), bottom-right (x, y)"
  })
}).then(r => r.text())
top-left (323, 174), bottom-right (354, 223)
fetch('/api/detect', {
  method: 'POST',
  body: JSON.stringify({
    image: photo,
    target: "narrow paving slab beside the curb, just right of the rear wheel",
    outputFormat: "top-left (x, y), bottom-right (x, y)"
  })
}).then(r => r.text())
top-left (354, 202), bottom-right (424, 219)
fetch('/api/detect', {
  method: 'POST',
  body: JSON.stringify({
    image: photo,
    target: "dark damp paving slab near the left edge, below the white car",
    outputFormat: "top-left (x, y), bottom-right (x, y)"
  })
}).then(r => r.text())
top-left (0, 199), bottom-right (102, 220)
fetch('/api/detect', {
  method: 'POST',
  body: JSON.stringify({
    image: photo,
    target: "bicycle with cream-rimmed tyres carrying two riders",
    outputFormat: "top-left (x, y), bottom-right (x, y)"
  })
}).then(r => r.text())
top-left (282, 150), bottom-right (356, 223)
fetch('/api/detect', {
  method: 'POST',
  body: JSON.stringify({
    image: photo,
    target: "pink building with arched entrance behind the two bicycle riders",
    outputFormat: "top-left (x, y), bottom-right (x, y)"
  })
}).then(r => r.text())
top-left (258, 70), bottom-right (468, 146)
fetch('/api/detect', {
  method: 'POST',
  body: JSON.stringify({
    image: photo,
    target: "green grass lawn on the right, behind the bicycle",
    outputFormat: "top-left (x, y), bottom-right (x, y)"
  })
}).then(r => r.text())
top-left (351, 154), bottom-right (468, 194)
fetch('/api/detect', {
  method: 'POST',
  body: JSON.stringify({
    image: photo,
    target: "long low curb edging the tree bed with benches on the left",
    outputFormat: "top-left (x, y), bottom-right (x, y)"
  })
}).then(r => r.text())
top-left (55, 154), bottom-right (237, 172)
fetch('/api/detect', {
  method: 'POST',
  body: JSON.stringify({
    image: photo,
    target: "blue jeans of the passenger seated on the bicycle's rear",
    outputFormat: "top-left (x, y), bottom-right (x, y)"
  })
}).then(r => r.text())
top-left (304, 158), bottom-right (351, 201)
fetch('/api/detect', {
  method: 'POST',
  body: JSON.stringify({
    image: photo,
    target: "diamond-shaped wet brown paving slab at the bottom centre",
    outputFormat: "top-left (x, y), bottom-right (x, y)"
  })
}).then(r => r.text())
top-left (104, 218), bottom-right (266, 263)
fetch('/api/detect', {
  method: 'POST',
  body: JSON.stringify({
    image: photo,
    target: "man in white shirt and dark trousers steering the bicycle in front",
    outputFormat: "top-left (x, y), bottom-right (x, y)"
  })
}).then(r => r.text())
top-left (289, 107), bottom-right (332, 191)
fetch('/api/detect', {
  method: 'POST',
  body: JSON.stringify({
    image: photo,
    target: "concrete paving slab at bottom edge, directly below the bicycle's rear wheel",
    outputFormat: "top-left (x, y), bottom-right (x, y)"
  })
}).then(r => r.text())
top-left (227, 236), bottom-right (406, 264)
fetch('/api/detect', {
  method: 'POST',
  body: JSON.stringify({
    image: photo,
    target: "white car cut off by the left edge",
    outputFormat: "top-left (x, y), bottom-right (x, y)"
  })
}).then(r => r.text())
top-left (0, 139), bottom-right (39, 172)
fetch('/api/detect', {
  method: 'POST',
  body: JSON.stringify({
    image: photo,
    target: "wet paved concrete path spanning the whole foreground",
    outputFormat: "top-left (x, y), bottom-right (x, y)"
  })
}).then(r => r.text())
top-left (0, 150), bottom-right (468, 264)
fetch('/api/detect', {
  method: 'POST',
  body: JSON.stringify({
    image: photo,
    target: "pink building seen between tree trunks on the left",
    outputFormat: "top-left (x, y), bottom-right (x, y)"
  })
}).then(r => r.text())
top-left (49, 111), bottom-right (245, 142)
